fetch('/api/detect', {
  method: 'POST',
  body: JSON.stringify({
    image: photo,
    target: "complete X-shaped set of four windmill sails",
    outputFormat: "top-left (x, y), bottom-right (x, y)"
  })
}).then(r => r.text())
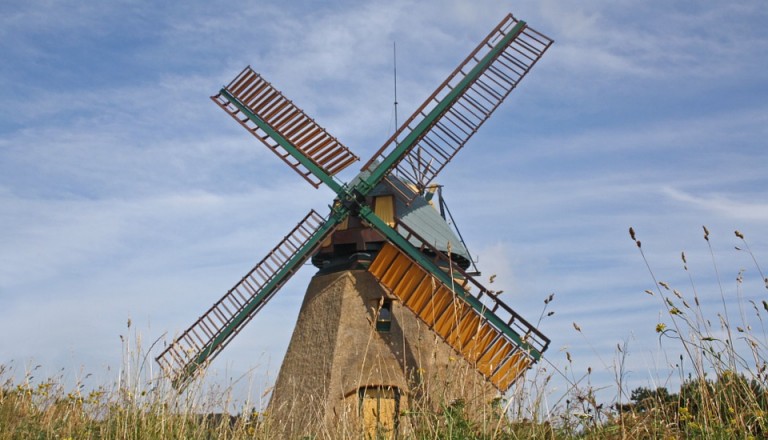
top-left (162, 14), bottom-right (552, 398)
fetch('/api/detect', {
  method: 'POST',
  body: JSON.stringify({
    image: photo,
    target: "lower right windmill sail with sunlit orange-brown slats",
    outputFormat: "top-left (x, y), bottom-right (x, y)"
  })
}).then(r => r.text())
top-left (368, 223), bottom-right (549, 392)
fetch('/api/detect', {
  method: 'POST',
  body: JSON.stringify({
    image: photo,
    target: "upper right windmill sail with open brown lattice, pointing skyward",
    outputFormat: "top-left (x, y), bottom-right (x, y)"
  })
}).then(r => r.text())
top-left (363, 14), bottom-right (552, 200)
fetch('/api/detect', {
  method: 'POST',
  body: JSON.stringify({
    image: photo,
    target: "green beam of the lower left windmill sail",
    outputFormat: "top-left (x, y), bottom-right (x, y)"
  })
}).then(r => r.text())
top-left (173, 210), bottom-right (349, 388)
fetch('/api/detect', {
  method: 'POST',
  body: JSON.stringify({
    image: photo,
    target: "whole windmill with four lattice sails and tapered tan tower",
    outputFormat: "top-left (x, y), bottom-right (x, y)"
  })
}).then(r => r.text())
top-left (156, 14), bottom-right (552, 434)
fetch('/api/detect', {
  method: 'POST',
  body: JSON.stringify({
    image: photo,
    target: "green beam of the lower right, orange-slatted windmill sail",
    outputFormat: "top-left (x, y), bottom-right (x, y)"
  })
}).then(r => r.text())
top-left (360, 206), bottom-right (541, 361)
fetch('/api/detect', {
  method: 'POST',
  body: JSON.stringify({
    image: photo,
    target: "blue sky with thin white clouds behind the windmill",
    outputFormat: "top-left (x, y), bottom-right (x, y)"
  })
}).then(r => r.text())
top-left (0, 0), bottom-right (768, 412)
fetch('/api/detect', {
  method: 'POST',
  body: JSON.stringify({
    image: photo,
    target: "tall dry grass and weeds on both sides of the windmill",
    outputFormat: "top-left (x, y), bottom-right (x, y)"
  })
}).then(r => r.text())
top-left (0, 228), bottom-right (768, 440)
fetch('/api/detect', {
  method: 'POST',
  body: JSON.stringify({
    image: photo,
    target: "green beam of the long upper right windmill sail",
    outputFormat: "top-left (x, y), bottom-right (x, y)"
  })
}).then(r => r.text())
top-left (356, 20), bottom-right (526, 195)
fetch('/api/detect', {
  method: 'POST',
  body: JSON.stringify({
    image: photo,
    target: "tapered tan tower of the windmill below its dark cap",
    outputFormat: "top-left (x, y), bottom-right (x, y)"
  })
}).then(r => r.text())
top-left (267, 270), bottom-right (499, 438)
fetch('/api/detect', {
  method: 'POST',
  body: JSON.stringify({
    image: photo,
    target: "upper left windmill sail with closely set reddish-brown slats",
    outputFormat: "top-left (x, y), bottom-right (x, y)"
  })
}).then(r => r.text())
top-left (211, 66), bottom-right (358, 188)
